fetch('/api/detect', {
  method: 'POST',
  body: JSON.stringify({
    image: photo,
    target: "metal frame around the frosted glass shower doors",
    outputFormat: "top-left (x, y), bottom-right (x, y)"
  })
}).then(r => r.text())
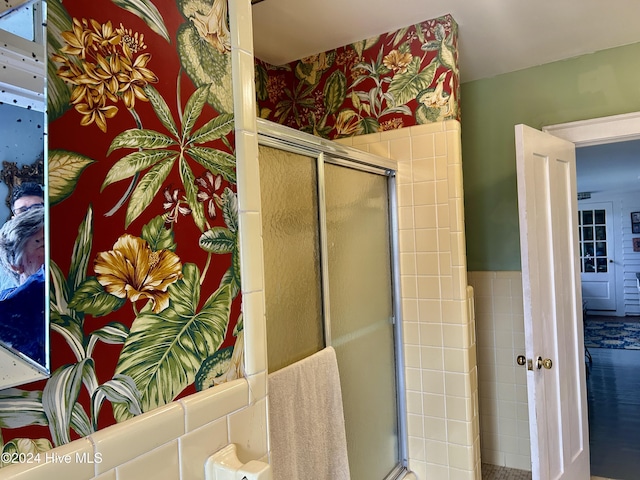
top-left (257, 119), bottom-right (409, 480)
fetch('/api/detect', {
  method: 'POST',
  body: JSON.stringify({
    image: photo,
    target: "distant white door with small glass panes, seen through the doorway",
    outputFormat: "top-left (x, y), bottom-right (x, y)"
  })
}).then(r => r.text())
top-left (578, 202), bottom-right (617, 315)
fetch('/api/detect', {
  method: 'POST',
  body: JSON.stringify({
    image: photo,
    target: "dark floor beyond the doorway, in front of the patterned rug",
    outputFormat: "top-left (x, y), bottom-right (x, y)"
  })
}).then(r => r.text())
top-left (587, 348), bottom-right (640, 480)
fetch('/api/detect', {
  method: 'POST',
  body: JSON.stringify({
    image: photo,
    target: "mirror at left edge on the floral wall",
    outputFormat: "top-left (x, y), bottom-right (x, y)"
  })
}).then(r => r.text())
top-left (0, 0), bottom-right (50, 389)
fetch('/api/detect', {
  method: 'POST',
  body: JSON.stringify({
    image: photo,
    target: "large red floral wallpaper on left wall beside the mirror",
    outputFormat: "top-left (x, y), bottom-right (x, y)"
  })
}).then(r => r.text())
top-left (0, 0), bottom-right (243, 459)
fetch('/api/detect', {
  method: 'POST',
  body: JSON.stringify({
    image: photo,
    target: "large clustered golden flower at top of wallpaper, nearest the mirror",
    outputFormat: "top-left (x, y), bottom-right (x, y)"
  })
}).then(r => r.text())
top-left (51, 18), bottom-right (158, 132)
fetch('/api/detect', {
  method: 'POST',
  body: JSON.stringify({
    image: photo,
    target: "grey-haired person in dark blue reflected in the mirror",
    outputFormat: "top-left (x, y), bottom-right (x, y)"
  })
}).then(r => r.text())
top-left (0, 206), bottom-right (45, 365)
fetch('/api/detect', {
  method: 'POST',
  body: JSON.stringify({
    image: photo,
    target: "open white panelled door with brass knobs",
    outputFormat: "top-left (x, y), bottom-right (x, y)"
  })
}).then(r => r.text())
top-left (516, 125), bottom-right (589, 480)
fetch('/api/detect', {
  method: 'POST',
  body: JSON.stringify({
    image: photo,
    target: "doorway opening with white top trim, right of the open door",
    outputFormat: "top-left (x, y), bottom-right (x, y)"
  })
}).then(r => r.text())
top-left (545, 114), bottom-right (640, 479)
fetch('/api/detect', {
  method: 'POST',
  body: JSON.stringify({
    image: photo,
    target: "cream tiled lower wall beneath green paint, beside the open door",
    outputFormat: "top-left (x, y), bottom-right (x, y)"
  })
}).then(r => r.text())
top-left (468, 272), bottom-right (531, 471)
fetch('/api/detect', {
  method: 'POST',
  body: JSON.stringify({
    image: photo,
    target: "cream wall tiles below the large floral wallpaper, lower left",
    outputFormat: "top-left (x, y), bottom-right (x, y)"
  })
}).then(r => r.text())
top-left (0, 379), bottom-right (267, 480)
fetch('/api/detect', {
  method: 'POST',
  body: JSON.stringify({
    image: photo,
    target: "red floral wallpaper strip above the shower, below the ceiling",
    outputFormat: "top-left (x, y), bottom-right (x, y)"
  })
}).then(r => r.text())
top-left (256, 15), bottom-right (460, 139)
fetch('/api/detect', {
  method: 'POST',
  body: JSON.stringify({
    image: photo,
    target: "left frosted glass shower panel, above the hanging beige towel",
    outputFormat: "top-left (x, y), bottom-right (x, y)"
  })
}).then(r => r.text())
top-left (259, 146), bottom-right (324, 372)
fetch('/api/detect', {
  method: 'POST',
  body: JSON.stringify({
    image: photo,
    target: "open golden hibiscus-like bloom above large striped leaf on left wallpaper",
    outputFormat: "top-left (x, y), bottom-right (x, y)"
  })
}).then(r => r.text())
top-left (94, 234), bottom-right (182, 313)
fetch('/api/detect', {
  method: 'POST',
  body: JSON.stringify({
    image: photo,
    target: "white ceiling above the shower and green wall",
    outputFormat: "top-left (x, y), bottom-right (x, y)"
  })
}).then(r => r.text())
top-left (252, 0), bottom-right (640, 82)
